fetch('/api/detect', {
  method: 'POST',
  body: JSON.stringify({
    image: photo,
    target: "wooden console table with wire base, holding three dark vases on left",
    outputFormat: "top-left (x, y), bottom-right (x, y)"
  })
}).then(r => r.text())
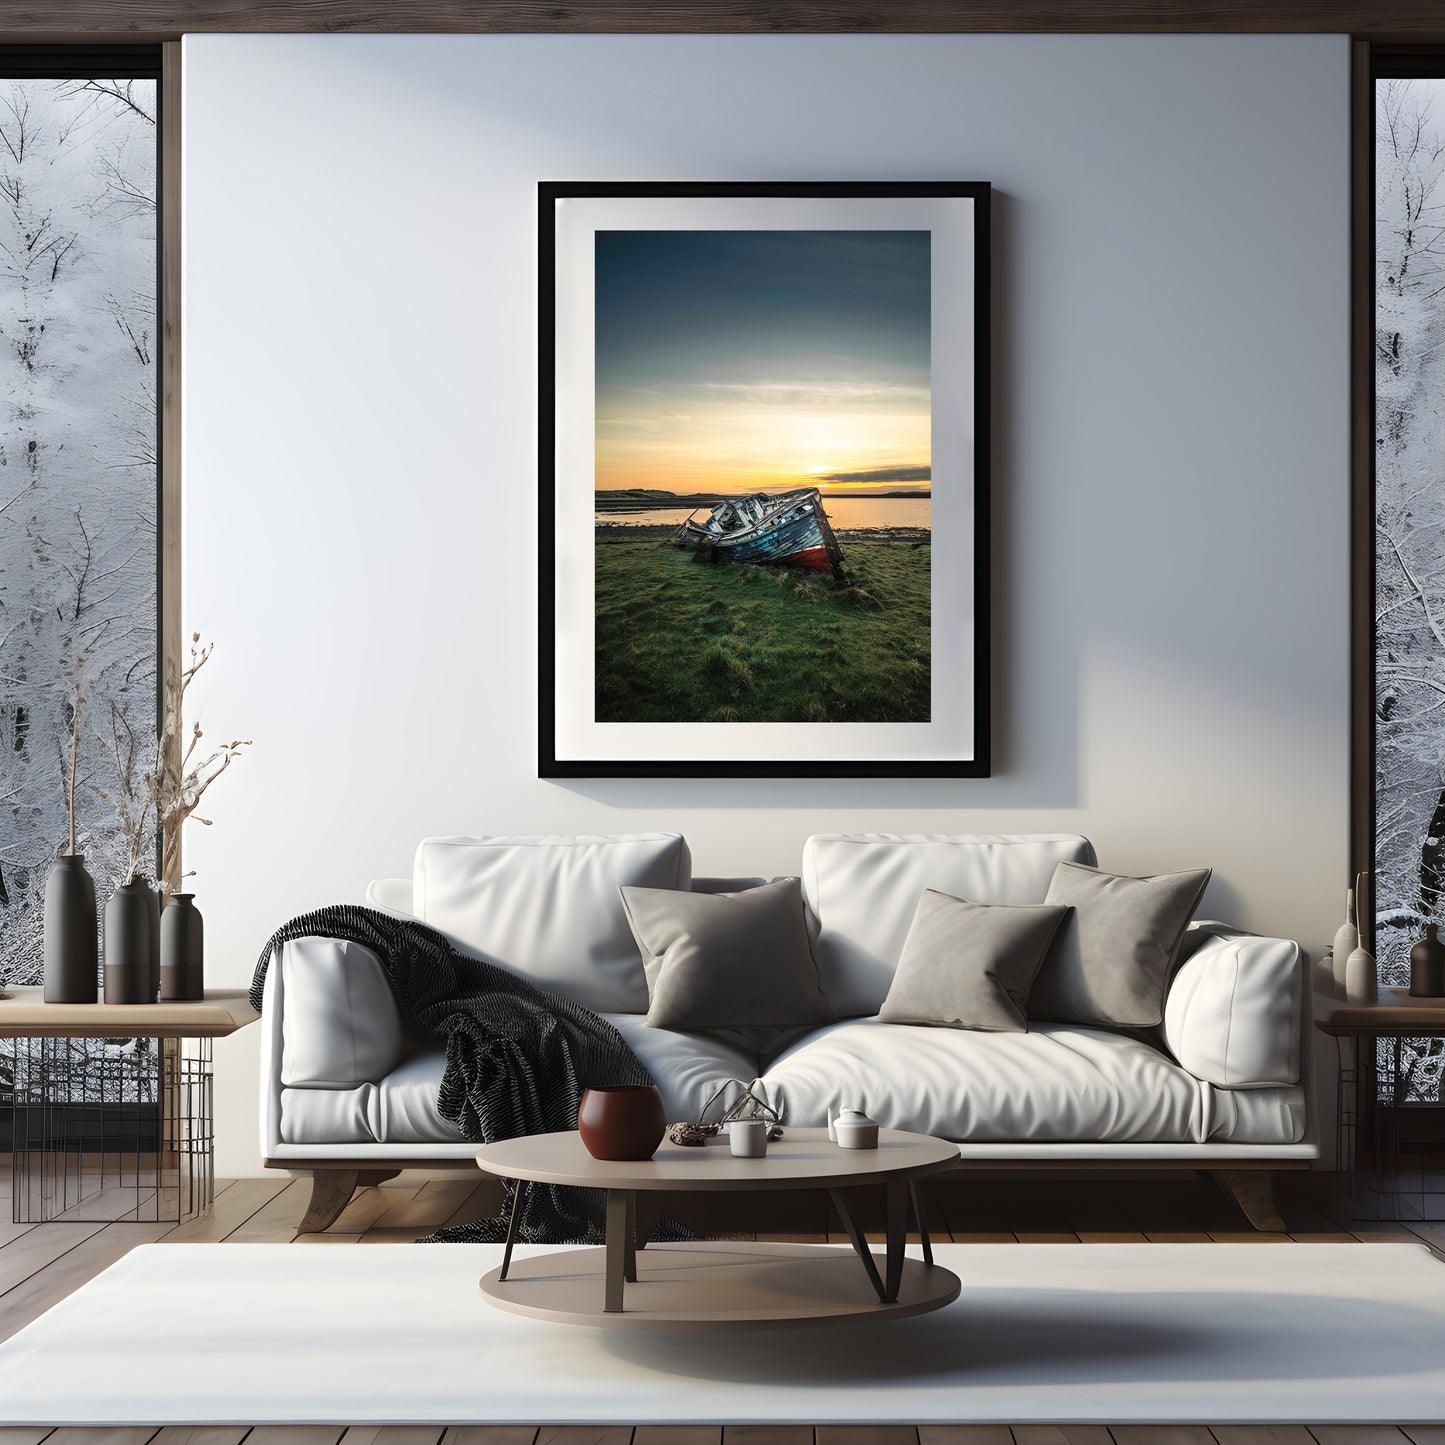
top-left (0, 988), bottom-right (260, 1224)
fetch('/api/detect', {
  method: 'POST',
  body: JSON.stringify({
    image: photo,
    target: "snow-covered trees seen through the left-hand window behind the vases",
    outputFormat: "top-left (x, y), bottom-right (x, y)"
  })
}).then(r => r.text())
top-left (0, 81), bottom-right (158, 983)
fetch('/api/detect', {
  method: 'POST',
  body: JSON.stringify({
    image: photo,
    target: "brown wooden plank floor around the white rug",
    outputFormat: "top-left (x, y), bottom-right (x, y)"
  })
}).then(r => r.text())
top-left (0, 1169), bottom-right (1445, 1445)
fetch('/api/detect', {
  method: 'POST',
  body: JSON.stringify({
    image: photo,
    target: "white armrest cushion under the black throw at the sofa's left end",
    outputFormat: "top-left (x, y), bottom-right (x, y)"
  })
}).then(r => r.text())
top-left (280, 938), bottom-right (407, 1090)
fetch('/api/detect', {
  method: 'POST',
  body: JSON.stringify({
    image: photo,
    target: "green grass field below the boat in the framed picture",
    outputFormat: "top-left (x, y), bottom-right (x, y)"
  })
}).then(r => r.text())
top-left (595, 538), bottom-right (931, 723)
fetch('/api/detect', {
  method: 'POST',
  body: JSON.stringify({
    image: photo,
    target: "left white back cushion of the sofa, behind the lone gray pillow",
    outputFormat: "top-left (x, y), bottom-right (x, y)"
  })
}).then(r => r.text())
top-left (412, 832), bottom-right (692, 1013)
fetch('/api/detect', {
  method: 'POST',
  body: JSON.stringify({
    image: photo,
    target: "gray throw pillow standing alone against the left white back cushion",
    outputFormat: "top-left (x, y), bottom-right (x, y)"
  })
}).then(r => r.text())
top-left (621, 879), bottom-right (832, 1032)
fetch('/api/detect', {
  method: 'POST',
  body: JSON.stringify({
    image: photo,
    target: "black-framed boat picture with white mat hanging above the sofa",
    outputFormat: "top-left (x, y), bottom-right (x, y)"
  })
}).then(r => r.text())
top-left (539, 182), bottom-right (990, 777)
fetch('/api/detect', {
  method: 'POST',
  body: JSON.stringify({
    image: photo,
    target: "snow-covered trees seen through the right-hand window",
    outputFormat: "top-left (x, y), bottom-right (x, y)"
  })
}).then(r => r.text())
top-left (1374, 81), bottom-right (1445, 1097)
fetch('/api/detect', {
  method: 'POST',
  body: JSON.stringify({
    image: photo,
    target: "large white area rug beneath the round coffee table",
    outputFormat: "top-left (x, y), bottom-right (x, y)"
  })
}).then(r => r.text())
top-left (0, 1244), bottom-right (1445, 1425)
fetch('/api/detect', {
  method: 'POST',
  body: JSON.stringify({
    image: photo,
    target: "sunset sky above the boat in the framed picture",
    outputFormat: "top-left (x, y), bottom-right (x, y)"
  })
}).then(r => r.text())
top-left (597, 231), bottom-right (931, 494)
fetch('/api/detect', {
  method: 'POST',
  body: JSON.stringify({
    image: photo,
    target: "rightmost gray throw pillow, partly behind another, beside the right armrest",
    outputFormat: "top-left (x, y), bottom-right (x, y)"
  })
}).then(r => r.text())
top-left (1029, 863), bottom-right (1211, 1029)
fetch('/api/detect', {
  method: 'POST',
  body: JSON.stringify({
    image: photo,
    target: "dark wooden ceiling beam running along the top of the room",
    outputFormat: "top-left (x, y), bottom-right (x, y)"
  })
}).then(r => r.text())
top-left (0, 0), bottom-right (1445, 43)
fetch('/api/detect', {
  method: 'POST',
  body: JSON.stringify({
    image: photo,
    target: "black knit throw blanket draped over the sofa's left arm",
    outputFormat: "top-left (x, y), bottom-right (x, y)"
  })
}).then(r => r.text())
top-left (251, 905), bottom-right (673, 1244)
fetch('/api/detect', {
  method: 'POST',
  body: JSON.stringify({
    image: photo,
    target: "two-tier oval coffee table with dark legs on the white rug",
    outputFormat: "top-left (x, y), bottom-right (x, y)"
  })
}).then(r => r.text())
top-left (477, 1129), bottom-right (959, 1329)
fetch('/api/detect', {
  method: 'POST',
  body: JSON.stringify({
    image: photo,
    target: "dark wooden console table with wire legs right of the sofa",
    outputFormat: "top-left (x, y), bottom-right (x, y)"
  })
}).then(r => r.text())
top-left (1315, 988), bottom-right (1445, 1218)
